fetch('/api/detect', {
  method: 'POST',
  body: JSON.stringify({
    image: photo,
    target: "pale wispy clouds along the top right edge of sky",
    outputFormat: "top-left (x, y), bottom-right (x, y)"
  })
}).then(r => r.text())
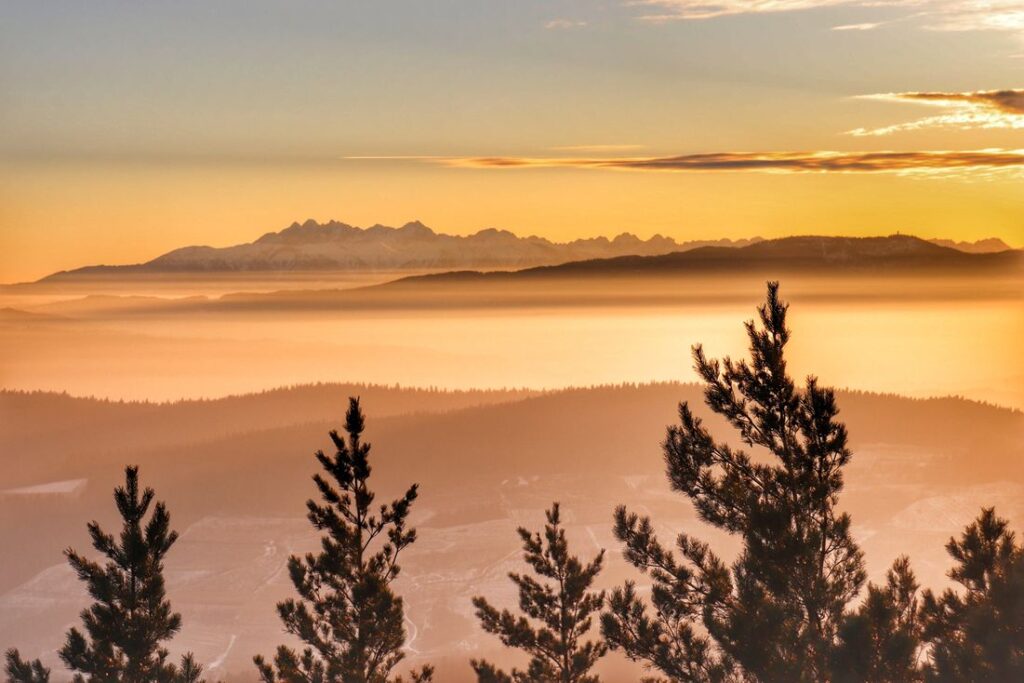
top-left (626, 0), bottom-right (1024, 31)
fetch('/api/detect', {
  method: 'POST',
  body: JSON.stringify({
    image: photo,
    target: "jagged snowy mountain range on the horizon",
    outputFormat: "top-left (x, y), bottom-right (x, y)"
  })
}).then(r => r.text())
top-left (41, 220), bottom-right (1010, 282)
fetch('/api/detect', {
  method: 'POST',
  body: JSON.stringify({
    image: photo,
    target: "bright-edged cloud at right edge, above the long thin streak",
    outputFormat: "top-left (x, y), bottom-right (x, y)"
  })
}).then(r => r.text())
top-left (848, 89), bottom-right (1024, 136)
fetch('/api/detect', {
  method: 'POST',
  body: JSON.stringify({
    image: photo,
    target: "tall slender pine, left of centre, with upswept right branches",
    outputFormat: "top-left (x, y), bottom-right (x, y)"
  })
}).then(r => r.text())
top-left (254, 398), bottom-right (433, 683)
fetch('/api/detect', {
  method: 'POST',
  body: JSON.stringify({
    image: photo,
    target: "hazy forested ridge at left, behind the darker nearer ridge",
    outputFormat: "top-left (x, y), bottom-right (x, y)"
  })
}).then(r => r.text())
top-left (0, 383), bottom-right (537, 488)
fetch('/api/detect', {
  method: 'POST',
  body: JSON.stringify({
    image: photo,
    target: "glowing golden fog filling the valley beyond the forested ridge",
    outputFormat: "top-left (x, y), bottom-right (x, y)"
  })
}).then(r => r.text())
top-left (0, 252), bottom-right (1024, 408)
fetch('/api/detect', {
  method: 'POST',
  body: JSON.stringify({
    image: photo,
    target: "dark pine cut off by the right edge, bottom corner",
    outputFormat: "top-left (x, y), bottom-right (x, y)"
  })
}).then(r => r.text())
top-left (923, 508), bottom-right (1024, 683)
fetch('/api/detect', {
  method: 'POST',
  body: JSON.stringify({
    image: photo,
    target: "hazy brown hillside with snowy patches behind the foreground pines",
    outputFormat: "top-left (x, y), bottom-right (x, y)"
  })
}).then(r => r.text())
top-left (0, 358), bottom-right (1024, 681)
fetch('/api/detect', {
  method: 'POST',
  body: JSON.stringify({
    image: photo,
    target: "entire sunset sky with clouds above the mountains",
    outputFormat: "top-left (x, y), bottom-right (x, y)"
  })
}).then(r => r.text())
top-left (0, 0), bottom-right (1024, 282)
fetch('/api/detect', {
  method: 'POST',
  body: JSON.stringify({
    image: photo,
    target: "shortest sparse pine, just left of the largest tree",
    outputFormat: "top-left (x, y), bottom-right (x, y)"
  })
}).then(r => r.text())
top-left (472, 503), bottom-right (607, 683)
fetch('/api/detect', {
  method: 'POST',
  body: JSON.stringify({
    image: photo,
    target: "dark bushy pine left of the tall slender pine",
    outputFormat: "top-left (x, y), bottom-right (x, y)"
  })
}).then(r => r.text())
top-left (52, 467), bottom-right (202, 683)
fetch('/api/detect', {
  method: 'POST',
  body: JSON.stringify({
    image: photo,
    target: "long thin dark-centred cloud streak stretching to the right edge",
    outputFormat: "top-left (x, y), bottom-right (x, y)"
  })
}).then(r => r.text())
top-left (437, 150), bottom-right (1024, 175)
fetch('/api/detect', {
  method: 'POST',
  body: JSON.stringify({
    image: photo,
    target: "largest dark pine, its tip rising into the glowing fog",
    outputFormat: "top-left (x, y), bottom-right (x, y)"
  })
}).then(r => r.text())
top-left (602, 283), bottom-right (865, 683)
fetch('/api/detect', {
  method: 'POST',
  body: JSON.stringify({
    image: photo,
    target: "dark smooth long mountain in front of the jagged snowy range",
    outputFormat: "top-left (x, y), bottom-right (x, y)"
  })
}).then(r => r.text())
top-left (28, 234), bottom-right (1011, 322)
